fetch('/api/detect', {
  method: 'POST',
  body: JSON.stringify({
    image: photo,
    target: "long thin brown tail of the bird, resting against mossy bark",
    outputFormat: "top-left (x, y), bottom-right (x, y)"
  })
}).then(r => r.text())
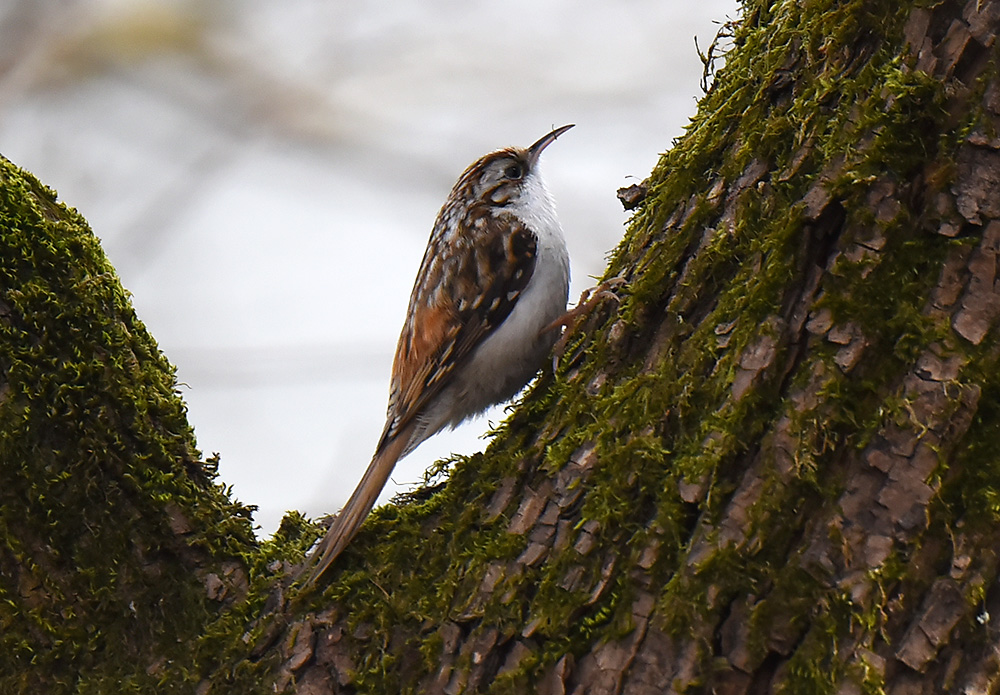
top-left (305, 433), bottom-right (409, 586)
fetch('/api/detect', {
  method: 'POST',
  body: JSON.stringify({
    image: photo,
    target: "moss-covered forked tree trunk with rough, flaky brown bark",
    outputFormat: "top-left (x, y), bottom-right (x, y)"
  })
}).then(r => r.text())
top-left (0, 0), bottom-right (1000, 694)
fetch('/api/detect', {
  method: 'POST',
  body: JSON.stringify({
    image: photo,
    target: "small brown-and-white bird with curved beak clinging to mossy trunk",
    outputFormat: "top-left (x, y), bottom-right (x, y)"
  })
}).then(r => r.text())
top-left (306, 124), bottom-right (573, 586)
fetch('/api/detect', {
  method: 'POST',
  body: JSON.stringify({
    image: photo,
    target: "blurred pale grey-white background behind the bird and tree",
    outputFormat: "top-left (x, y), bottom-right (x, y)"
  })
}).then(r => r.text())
top-left (0, 0), bottom-right (737, 536)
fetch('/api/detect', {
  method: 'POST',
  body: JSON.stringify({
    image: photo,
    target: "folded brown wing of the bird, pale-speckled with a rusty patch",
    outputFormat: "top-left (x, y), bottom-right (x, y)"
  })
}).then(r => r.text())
top-left (379, 209), bottom-right (538, 449)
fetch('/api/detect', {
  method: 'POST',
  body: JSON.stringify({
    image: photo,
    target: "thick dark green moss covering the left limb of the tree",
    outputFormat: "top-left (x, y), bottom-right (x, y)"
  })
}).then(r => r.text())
top-left (0, 159), bottom-right (262, 693)
